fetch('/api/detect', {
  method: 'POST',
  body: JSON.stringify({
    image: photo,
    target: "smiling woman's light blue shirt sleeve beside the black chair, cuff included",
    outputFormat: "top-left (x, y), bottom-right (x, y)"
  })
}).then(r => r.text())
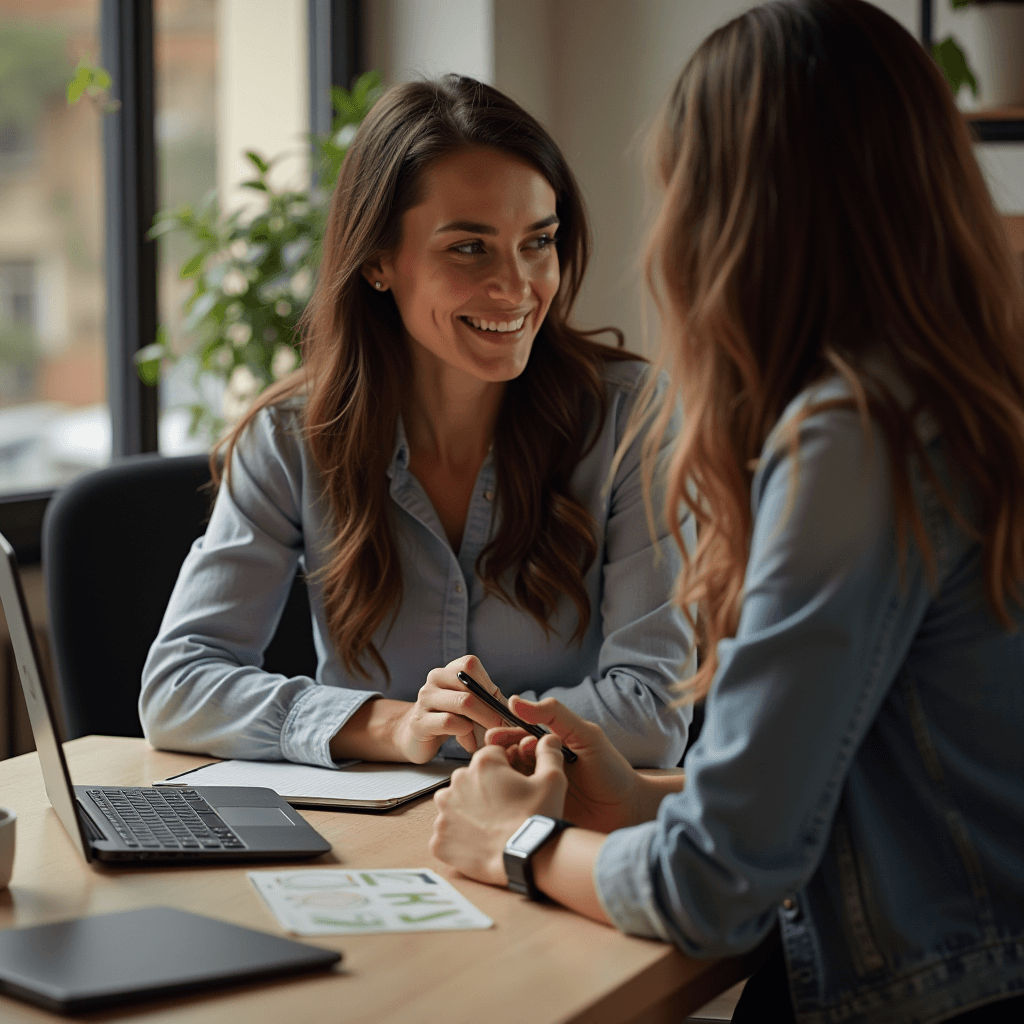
top-left (139, 410), bottom-right (377, 767)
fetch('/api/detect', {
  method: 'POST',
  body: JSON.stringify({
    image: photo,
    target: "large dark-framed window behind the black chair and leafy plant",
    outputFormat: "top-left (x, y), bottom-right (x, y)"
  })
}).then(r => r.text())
top-left (0, 0), bottom-right (361, 562)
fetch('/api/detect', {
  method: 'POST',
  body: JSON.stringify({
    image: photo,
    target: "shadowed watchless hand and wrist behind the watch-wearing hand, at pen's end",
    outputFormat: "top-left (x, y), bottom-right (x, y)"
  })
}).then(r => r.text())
top-left (486, 697), bottom-right (682, 833)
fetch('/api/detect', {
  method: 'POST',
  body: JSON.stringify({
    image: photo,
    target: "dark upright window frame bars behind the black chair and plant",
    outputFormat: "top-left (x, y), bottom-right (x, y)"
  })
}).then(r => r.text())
top-left (0, 0), bottom-right (364, 564)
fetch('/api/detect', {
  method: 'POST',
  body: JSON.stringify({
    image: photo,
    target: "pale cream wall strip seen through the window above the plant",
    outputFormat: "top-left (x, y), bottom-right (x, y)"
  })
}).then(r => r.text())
top-left (217, 0), bottom-right (309, 213)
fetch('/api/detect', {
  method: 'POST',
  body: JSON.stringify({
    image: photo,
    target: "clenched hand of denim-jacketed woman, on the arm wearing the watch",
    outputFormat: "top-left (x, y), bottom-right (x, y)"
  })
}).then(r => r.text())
top-left (430, 736), bottom-right (566, 886)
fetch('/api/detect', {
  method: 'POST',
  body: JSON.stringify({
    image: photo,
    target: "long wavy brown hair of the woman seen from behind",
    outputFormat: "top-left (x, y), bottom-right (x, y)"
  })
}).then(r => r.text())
top-left (646, 0), bottom-right (1024, 698)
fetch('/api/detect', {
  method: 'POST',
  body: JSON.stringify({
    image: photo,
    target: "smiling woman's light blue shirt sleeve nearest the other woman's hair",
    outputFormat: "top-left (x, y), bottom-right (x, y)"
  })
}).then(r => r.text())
top-left (523, 378), bottom-right (696, 768)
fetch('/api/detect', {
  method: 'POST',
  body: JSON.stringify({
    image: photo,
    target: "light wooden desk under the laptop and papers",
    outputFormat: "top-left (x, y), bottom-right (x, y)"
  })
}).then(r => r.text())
top-left (0, 736), bottom-right (770, 1024)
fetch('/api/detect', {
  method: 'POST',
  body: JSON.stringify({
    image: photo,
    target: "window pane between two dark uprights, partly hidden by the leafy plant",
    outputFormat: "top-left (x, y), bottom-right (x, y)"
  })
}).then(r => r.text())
top-left (153, 0), bottom-right (309, 455)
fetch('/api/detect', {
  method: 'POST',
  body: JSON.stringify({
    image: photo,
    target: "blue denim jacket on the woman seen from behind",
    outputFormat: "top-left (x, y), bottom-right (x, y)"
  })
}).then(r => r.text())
top-left (595, 382), bottom-right (1024, 1024)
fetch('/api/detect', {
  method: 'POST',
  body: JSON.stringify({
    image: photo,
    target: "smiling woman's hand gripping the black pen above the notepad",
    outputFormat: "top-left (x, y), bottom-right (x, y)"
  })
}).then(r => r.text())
top-left (394, 654), bottom-right (504, 764)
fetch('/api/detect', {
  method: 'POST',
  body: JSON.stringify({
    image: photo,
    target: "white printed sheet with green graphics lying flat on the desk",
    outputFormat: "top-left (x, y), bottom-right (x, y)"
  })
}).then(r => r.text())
top-left (249, 867), bottom-right (495, 935)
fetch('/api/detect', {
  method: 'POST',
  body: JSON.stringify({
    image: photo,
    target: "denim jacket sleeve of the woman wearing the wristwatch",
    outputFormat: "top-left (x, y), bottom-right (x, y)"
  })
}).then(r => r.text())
top-left (594, 411), bottom-right (931, 955)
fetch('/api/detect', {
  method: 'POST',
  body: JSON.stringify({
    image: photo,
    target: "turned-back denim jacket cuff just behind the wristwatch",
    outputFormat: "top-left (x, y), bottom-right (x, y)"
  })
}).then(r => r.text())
top-left (594, 821), bottom-right (672, 942)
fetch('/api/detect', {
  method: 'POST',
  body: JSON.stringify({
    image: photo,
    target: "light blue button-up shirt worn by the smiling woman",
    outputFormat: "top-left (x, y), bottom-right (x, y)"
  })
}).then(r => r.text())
top-left (139, 361), bottom-right (695, 767)
